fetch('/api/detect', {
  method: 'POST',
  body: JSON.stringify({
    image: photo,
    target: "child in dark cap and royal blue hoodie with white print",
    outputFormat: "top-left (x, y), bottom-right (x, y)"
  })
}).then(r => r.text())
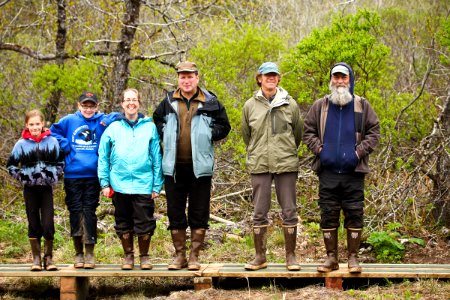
top-left (50, 92), bottom-right (117, 269)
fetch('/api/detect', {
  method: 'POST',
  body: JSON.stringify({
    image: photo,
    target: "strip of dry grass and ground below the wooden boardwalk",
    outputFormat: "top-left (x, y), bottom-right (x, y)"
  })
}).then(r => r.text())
top-left (0, 278), bottom-right (450, 300)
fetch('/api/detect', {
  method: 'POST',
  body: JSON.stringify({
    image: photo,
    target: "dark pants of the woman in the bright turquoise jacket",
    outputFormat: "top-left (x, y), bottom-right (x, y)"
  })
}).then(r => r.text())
top-left (112, 192), bottom-right (156, 237)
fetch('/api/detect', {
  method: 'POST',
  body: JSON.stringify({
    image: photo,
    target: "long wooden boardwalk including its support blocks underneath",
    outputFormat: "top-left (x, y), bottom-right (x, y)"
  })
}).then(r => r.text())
top-left (0, 263), bottom-right (450, 299)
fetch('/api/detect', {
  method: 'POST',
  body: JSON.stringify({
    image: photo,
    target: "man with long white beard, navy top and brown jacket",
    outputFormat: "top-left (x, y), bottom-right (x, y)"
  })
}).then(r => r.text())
top-left (303, 62), bottom-right (380, 273)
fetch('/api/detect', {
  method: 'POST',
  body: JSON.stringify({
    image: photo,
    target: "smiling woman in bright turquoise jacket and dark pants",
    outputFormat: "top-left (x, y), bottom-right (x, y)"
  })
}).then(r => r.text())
top-left (98, 89), bottom-right (163, 270)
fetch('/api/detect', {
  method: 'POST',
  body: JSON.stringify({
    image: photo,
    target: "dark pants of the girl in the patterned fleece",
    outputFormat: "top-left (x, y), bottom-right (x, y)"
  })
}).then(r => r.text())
top-left (23, 186), bottom-right (55, 240)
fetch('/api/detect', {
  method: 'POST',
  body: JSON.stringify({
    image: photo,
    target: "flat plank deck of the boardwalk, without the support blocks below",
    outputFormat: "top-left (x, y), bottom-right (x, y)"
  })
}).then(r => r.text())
top-left (0, 264), bottom-right (450, 278)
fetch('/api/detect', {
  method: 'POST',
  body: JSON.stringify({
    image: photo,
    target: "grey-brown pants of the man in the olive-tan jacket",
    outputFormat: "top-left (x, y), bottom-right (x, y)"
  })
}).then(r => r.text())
top-left (251, 172), bottom-right (298, 225)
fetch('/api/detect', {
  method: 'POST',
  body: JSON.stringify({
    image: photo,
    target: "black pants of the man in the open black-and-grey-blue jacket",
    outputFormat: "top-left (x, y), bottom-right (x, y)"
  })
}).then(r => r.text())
top-left (164, 164), bottom-right (212, 229)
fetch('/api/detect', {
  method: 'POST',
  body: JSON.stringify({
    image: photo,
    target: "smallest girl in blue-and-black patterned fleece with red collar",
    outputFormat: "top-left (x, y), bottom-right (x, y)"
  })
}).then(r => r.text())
top-left (6, 110), bottom-right (64, 271)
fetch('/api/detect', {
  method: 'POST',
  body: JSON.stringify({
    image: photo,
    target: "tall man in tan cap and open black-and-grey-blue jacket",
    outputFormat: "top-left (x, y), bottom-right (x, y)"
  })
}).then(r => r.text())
top-left (153, 61), bottom-right (231, 270)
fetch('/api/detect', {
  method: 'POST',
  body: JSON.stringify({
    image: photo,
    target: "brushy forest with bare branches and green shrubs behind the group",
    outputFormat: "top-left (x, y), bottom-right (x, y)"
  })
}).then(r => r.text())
top-left (0, 0), bottom-right (450, 300)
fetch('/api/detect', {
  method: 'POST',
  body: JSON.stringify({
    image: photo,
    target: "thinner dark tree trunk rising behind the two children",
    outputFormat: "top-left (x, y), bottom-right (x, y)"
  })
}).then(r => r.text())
top-left (44, 0), bottom-right (67, 123)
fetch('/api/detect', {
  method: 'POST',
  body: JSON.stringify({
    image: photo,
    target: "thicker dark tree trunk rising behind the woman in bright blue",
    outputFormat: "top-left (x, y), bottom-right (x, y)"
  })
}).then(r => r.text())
top-left (105, 0), bottom-right (141, 111)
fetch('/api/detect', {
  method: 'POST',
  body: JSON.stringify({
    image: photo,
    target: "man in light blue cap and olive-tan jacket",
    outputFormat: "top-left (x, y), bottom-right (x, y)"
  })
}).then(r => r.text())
top-left (242, 62), bottom-right (302, 270)
